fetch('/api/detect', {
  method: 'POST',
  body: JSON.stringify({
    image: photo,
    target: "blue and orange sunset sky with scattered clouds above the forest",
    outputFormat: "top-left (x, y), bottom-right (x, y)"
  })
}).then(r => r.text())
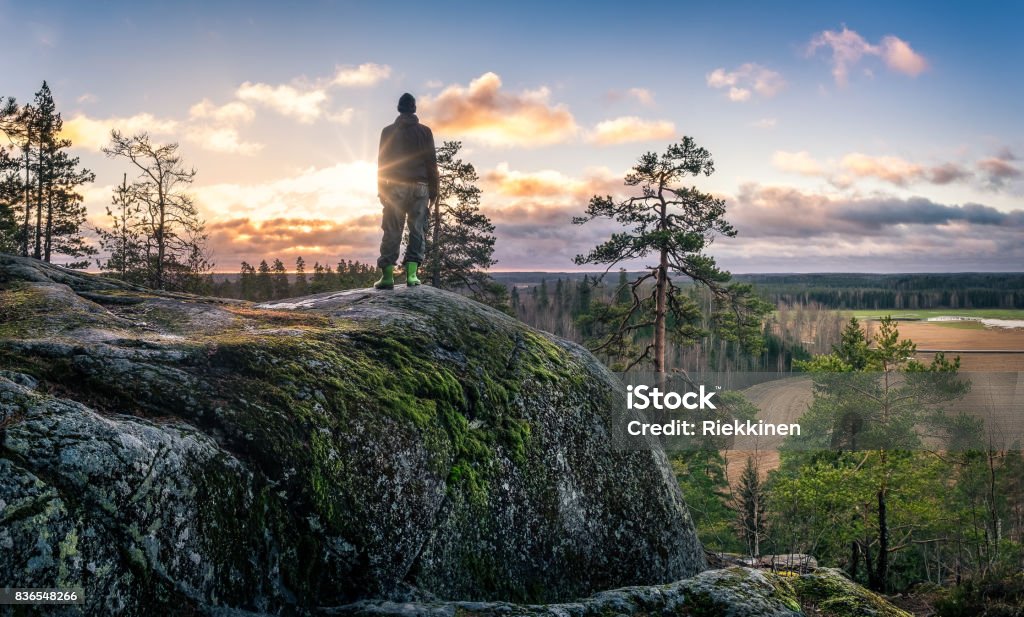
top-left (0, 0), bottom-right (1024, 272)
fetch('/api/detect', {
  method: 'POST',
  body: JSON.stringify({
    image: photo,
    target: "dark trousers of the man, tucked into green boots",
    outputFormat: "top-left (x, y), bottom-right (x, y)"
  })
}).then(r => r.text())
top-left (377, 182), bottom-right (430, 268)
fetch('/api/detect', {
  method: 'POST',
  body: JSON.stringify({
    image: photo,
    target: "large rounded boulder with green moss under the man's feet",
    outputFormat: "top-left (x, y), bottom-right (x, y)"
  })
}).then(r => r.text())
top-left (0, 256), bottom-right (706, 615)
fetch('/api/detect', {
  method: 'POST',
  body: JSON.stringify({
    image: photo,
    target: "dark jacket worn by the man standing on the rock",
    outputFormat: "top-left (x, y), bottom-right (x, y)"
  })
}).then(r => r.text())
top-left (377, 114), bottom-right (438, 199)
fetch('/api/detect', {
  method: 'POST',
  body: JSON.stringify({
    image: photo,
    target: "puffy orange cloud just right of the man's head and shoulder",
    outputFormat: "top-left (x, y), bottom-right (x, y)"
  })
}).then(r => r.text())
top-left (419, 73), bottom-right (579, 146)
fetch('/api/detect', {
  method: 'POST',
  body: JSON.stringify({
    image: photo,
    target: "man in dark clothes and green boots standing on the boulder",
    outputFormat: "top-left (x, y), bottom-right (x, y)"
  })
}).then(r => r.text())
top-left (374, 92), bottom-right (438, 290)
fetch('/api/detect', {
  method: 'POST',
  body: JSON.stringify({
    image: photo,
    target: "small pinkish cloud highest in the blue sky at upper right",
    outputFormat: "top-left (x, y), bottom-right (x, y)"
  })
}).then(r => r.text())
top-left (807, 26), bottom-right (928, 86)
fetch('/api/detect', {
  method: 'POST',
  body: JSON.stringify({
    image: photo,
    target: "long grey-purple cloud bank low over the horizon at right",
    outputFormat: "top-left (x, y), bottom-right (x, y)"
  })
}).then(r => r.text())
top-left (715, 184), bottom-right (1024, 272)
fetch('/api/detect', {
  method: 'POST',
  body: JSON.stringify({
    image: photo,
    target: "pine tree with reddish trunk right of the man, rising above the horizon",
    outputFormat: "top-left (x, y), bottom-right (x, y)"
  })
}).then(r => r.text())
top-left (573, 137), bottom-right (772, 372)
